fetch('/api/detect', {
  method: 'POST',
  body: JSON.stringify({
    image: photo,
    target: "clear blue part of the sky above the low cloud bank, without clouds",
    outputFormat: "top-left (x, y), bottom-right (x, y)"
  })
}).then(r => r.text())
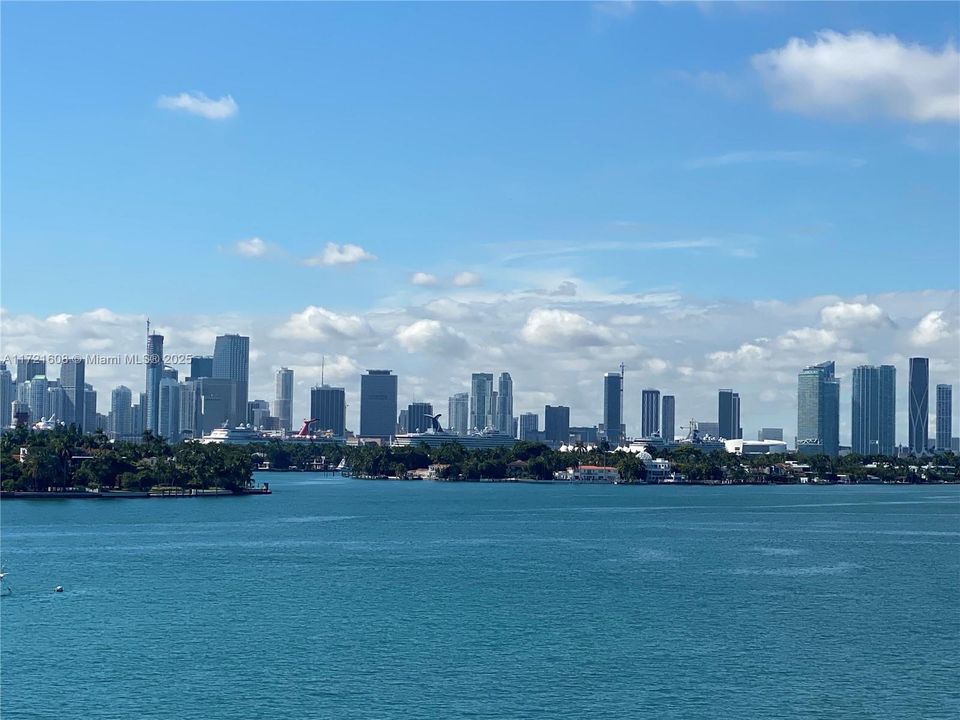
top-left (2, 3), bottom-right (960, 313)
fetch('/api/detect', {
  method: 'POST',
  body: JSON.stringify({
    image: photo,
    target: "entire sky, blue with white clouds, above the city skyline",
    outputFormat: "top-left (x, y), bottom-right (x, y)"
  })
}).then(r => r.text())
top-left (0, 3), bottom-right (960, 442)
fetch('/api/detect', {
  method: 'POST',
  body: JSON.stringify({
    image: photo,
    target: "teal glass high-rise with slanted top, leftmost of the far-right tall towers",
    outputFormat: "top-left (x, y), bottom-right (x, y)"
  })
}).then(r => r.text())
top-left (797, 360), bottom-right (840, 457)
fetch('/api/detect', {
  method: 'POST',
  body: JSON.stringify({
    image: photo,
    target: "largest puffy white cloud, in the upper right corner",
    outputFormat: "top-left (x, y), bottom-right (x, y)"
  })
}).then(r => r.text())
top-left (752, 30), bottom-right (960, 122)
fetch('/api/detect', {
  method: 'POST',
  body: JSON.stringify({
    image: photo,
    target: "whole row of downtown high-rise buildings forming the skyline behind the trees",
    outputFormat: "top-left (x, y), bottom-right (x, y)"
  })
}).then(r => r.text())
top-left (0, 326), bottom-right (960, 457)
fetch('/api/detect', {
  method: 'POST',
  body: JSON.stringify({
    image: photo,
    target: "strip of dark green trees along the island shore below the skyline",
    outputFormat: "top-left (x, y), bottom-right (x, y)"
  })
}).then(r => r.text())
top-left (0, 428), bottom-right (960, 492)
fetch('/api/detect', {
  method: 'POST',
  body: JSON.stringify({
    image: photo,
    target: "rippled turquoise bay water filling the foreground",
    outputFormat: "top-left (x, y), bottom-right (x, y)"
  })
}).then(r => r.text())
top-left (0, 474), bottom-right (960, 720)
